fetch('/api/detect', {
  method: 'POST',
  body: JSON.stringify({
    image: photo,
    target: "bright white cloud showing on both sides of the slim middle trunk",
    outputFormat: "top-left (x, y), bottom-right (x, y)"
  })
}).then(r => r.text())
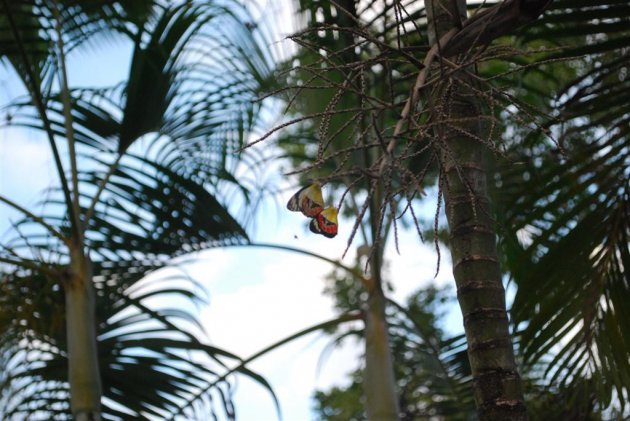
top-left (191, 202), bottom-right (459, 421)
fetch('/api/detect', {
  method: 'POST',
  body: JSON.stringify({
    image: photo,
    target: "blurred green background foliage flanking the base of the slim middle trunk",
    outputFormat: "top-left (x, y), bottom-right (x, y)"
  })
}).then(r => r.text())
top-left (314, 280), bottom-right (475, 420)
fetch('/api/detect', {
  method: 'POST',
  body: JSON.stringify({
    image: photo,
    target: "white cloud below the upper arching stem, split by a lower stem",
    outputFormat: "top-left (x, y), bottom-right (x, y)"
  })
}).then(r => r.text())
top-left (202, 246), bottom-right (356, 420)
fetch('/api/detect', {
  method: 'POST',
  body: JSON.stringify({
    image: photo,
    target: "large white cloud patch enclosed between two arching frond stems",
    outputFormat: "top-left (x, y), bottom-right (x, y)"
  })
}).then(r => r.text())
top-left (202, 251), bottom-right (333, 355)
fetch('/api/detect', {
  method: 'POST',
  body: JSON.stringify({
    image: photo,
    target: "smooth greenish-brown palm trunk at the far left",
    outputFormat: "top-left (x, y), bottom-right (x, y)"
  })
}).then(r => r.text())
top-left (64, 248), bottom-right (102, 421)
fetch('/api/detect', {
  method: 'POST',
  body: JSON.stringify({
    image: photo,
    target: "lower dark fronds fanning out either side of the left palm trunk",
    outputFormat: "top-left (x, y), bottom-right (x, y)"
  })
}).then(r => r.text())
top-left (1, 261), bottom-right (273, 419)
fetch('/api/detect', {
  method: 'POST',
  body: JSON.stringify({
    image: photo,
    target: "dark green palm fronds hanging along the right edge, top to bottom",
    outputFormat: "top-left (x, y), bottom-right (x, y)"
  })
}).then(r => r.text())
top-left (497, 1), bottom-right (630, 419)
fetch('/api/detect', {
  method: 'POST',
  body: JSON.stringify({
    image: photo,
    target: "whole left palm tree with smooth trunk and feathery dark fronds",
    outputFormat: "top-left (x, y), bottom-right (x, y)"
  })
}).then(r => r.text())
top-left (0, 0), bottom-right (280, 419)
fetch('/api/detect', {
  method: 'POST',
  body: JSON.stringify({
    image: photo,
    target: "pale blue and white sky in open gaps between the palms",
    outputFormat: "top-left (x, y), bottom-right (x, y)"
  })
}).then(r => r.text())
top-left (0, 4), bottom-right (462, 421)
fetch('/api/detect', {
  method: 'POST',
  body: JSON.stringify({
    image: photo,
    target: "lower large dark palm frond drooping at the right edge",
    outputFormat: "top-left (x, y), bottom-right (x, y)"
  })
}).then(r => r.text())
top-left (505, 127), bottom-right (630, 406)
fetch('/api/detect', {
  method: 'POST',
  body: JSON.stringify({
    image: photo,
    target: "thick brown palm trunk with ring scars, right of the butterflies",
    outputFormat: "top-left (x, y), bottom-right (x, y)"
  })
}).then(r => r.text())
top-left (427, 0), bottom-right (527, 421)
